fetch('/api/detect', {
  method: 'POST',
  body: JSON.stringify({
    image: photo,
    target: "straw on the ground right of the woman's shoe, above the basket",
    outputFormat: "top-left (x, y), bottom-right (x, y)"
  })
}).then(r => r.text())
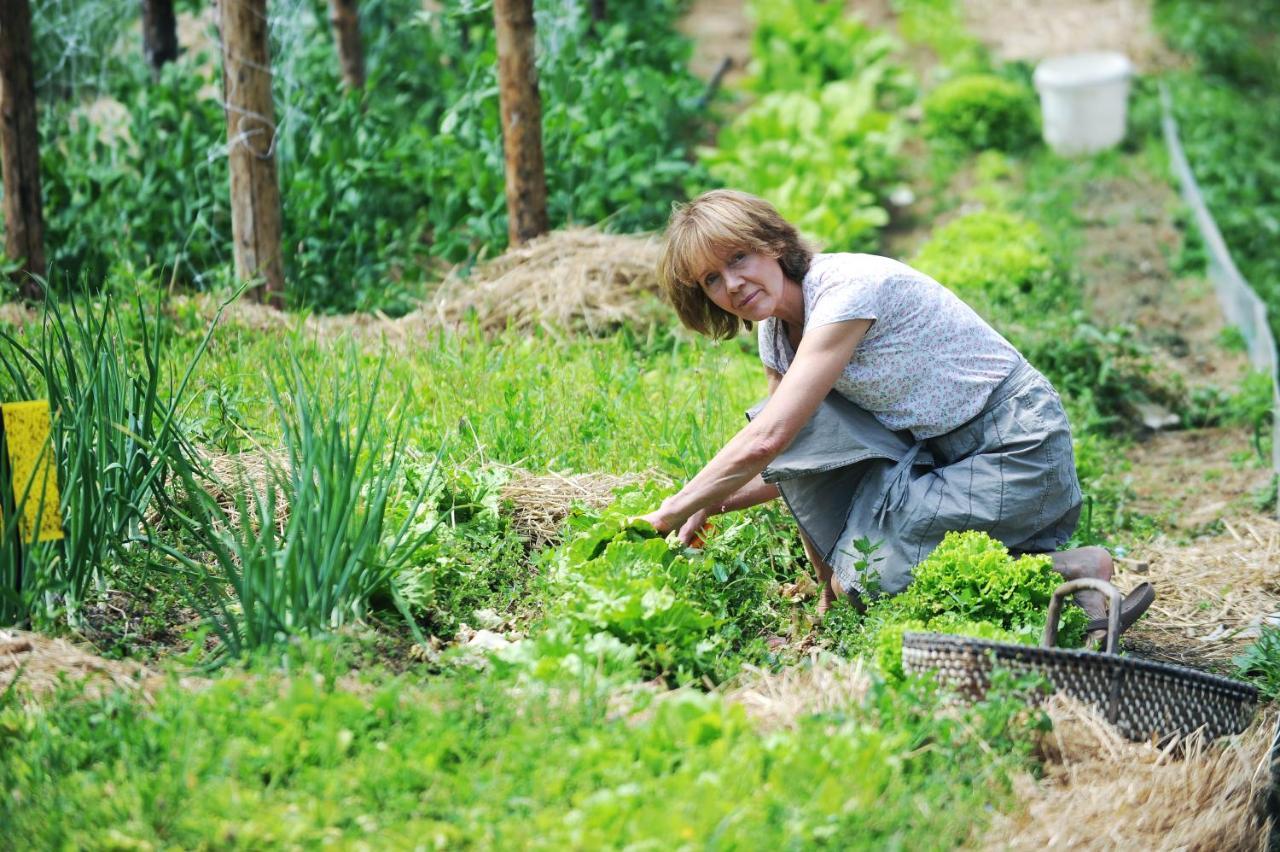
top-left (1116, 516), bottom-right (1280, 672)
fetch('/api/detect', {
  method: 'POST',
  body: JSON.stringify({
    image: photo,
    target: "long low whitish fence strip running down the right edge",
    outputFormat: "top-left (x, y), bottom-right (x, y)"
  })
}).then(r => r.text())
top-left (1160, 83), bottom-right (1280, 514)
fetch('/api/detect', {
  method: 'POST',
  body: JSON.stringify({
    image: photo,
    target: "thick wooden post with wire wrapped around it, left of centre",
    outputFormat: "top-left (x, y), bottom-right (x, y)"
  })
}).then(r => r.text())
top-left (216, 0), bottom-right (284, 303)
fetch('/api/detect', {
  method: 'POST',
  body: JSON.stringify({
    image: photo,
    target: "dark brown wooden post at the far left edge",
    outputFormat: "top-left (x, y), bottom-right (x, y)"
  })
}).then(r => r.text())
top-left (0, 0), bottom-right (45, 299)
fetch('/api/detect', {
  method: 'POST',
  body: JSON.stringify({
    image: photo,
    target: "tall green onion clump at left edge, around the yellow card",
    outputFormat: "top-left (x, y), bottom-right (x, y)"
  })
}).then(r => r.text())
top-left (0, 299), bottom-right (212, 626)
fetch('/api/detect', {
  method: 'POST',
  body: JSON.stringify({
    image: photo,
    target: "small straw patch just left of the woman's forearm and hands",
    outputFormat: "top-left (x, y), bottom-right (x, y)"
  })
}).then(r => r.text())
top-left (499, 468), bottom-right (669, 550)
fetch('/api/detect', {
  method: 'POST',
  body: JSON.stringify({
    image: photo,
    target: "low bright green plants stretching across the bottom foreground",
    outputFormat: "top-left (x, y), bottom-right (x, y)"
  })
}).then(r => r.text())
top-left (0, 647), bottom-right (1042, 849)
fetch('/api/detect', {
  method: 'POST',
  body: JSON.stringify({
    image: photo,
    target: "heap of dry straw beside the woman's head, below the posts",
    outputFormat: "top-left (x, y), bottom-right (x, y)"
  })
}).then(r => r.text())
top-left (435, 228), bottom-right (660, 334)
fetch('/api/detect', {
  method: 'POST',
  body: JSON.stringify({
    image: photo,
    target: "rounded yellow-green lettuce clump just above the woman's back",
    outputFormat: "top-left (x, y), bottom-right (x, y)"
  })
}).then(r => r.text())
top-left (911, 210), bottom-right (1062, 315)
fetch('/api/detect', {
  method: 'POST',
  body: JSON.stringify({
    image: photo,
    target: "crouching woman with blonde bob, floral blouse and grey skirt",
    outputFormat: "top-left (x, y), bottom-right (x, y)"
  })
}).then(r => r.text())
top-left (644, 189), bottom-right (1153, 631)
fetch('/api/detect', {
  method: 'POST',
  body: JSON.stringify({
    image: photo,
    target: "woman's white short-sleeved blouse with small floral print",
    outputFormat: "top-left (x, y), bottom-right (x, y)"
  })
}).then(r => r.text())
top-left (759, 253), bottom-right (1021, 440)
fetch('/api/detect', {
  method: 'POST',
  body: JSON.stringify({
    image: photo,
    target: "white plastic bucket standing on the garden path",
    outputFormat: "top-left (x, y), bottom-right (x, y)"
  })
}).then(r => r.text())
top-left (1034, 54), bottom-right (1133, 155)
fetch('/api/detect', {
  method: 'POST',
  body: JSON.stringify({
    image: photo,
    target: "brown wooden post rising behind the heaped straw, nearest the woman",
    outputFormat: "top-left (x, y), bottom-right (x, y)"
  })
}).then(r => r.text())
top-left (493, 0), bottom-right (548, 246)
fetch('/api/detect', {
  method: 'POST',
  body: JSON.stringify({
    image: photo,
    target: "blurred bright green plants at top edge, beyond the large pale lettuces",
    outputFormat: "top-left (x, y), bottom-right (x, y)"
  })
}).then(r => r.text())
top-left (746, 0), bottom-right (911, 97)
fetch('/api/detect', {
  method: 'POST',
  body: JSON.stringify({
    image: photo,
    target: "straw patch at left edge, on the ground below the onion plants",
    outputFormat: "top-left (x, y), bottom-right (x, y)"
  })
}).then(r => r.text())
top-left (0, 631), bottom-right (163, 698)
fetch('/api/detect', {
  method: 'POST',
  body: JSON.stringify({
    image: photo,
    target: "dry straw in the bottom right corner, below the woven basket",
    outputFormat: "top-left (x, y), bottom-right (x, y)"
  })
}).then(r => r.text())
top-left (980, 696), bottom-right (1275, 849)
